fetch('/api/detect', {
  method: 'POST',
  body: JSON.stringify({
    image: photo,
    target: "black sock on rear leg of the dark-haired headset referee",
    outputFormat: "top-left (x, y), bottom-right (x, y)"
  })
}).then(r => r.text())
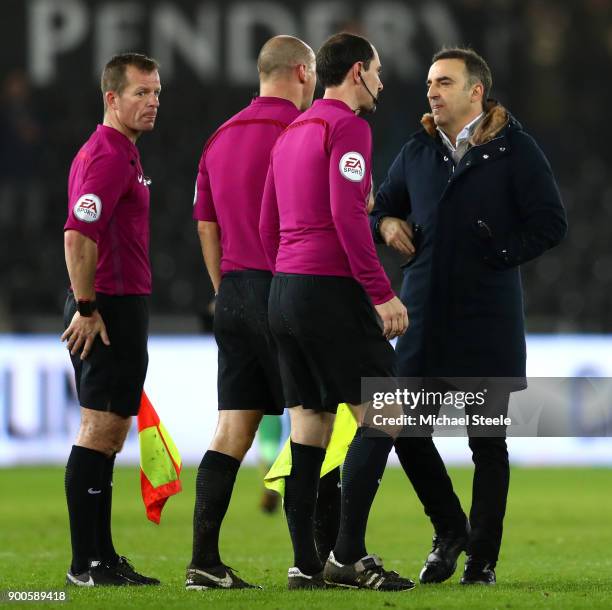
top-left (285, 441), bottom-right (325, 576)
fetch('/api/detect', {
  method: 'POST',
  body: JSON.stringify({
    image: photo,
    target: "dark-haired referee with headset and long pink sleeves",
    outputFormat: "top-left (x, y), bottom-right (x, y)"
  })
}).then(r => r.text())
top-left (259, 33), bottom-right (414, 591)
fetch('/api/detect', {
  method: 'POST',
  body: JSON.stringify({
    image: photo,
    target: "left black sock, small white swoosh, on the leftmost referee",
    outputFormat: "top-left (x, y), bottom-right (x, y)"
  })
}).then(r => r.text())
top-left (65, 445), bottom-right (107, 574)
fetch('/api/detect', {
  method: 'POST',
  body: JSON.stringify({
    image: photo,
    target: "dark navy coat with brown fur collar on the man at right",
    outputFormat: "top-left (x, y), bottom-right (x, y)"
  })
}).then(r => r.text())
top-left (370, 103), bottom-right (567, 378)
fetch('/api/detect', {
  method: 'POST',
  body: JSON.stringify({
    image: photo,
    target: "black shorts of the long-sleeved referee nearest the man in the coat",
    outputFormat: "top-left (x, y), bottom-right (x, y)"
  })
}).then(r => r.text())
top-left (268, 273), bottom-right (395, 413)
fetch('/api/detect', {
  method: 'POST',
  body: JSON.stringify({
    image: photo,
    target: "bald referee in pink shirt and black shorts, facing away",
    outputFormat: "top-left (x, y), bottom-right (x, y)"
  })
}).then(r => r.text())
top-left (185, 36), bottom-right (339, 590)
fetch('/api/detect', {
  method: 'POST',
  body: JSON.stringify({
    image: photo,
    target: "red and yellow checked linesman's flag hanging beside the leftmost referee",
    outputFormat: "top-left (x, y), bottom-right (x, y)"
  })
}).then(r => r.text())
top-left (138, 391), bottom-right (182, 525)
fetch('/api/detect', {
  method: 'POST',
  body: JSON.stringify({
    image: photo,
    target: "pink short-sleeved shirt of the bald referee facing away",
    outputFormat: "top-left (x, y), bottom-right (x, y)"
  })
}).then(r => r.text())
top-left (193, 97), bottom-right (300, 274)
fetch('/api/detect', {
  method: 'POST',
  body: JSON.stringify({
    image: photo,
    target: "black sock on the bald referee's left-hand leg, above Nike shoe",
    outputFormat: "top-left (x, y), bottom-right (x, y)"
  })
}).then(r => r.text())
top-left (191, 450), bottom-right (240, 568)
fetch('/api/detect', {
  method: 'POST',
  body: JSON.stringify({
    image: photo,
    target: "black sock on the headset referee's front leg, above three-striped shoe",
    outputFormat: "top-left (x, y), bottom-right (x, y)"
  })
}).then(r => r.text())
top-left (334, 427), bottom-right (393, 564)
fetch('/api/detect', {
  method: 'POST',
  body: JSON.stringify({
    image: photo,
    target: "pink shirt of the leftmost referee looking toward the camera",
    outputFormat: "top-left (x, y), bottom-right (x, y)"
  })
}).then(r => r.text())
top-left (64, 125), bottom-right (151, 295)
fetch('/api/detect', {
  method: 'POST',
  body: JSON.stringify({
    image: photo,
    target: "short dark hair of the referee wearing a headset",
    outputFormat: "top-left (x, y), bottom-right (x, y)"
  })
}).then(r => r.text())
top-left (317, 32), bottom-right (374, 88)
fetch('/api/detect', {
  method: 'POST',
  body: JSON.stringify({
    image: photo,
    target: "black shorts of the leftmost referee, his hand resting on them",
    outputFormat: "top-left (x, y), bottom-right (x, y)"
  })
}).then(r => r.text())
top-left (64, 292), bottom-right (149, 417)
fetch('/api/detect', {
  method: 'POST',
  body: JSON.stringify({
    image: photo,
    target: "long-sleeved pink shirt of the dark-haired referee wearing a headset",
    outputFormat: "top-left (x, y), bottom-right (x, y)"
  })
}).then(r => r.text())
top-left (259, 100), bottom-right (395, 305)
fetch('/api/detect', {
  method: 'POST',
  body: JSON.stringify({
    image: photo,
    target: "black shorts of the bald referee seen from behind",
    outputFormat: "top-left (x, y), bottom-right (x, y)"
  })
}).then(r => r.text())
top-left (214, 270), bottom-right (284, 415)
